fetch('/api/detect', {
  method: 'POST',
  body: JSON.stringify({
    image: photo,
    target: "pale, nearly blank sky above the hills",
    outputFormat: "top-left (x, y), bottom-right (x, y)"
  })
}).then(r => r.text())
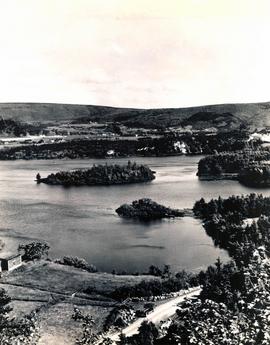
top-left (0, 0), bottom-right (270, 108)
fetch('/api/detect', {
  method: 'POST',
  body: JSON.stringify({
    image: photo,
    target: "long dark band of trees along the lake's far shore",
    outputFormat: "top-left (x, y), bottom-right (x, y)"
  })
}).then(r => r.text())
top-left (0, 132), bottom-right (253, 160)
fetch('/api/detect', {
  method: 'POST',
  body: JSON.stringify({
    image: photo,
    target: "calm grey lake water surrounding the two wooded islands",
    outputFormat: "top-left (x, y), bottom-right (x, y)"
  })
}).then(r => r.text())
top-left (0, 157), bottom-right (270, 271)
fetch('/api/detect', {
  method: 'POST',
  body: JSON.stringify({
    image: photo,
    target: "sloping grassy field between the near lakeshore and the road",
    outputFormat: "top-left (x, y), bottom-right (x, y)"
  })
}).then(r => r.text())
top-left (0, 261), bottom-right (158, 345)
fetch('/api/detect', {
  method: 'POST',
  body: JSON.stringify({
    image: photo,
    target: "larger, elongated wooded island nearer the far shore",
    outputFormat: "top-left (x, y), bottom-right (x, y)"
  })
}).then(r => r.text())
top-left (36, 161), bottom-right (155, 186)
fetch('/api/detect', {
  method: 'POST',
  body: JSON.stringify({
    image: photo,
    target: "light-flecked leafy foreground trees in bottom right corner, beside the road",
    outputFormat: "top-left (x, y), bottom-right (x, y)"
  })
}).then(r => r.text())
top-left (154, 249), bottom-right (270, 345)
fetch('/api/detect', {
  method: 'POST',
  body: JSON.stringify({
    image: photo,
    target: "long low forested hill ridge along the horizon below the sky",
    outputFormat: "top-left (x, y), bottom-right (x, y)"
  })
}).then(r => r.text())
top-left (0, 102), bottom-right (270, 130)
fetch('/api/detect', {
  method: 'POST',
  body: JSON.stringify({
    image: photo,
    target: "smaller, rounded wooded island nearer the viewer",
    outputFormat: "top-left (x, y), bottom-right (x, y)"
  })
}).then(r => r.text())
top-left (116, 198), bottom-right (184, 221)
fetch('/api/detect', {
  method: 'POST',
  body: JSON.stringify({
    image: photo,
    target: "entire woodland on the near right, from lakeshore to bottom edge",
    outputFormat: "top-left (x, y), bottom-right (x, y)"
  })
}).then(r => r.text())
top-left (116, 194), bottom-right (270, 345)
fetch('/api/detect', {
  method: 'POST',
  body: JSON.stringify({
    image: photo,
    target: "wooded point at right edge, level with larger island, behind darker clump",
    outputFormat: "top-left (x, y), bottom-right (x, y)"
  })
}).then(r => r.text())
top-left (198, 149), bottom-right (270, 176)
